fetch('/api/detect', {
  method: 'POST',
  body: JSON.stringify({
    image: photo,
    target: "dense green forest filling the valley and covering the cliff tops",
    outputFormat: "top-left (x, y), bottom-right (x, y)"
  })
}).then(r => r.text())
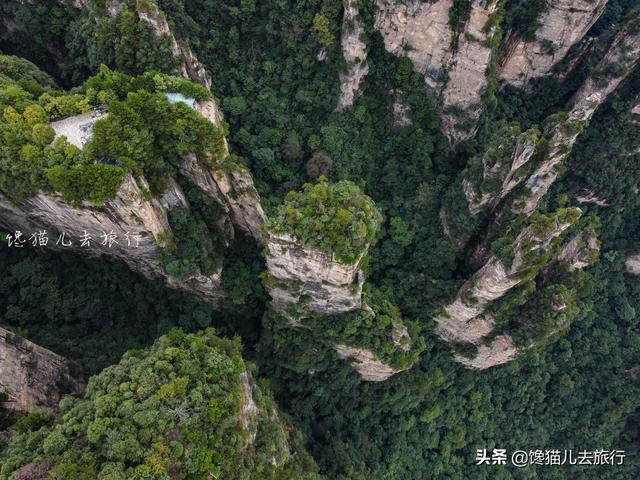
top-left (0, 0), bottom-right (640, 480)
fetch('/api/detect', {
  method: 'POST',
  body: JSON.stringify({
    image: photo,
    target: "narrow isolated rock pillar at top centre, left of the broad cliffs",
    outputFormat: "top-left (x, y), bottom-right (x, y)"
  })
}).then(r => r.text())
top-left (336, 0), bottom-right (369, 112)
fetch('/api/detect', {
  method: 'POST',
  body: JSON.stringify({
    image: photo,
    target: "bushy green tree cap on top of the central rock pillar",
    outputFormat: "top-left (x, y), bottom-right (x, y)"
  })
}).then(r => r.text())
top-left (265, 180), bottom-right (382, 263)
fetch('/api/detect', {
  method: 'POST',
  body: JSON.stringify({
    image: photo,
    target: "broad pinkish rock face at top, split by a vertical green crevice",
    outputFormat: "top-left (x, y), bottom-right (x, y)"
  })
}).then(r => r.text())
top-left (375, 0), bottom-right (499, 141)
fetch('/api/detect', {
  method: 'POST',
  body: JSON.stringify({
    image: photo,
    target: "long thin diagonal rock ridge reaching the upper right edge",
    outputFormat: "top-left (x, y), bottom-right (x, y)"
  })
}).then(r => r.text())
top-left (512, 14), bottom-right (640, 215)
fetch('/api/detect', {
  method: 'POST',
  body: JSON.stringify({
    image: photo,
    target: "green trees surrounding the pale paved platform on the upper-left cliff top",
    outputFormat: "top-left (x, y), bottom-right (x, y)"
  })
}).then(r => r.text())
top-left (0, 61), bottom-right (223, 205)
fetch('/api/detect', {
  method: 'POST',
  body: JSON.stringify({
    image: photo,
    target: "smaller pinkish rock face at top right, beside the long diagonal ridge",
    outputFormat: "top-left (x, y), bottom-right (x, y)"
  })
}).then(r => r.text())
top-left (499, 0), bottom-right (607, 87)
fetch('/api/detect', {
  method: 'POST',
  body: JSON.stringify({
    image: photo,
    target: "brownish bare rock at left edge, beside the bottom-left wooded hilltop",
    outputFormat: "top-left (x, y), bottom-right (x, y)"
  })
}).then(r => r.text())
top-left (0, 328), bottom-right (84, 413)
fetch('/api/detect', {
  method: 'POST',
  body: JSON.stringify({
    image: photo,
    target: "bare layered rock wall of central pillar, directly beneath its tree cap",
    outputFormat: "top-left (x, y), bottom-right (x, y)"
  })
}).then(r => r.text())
top-left (266, 234), bottom-right (366, 323)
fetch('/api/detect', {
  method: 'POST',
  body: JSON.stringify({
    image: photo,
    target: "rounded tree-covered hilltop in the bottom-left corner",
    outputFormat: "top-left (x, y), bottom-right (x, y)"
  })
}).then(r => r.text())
top-left (0, 329), bottom-right (322, 480)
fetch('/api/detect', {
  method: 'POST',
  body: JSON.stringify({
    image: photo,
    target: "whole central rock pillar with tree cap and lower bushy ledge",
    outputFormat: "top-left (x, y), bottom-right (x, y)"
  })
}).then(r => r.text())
top-left (264, 182), bottom-right (420, 381)
